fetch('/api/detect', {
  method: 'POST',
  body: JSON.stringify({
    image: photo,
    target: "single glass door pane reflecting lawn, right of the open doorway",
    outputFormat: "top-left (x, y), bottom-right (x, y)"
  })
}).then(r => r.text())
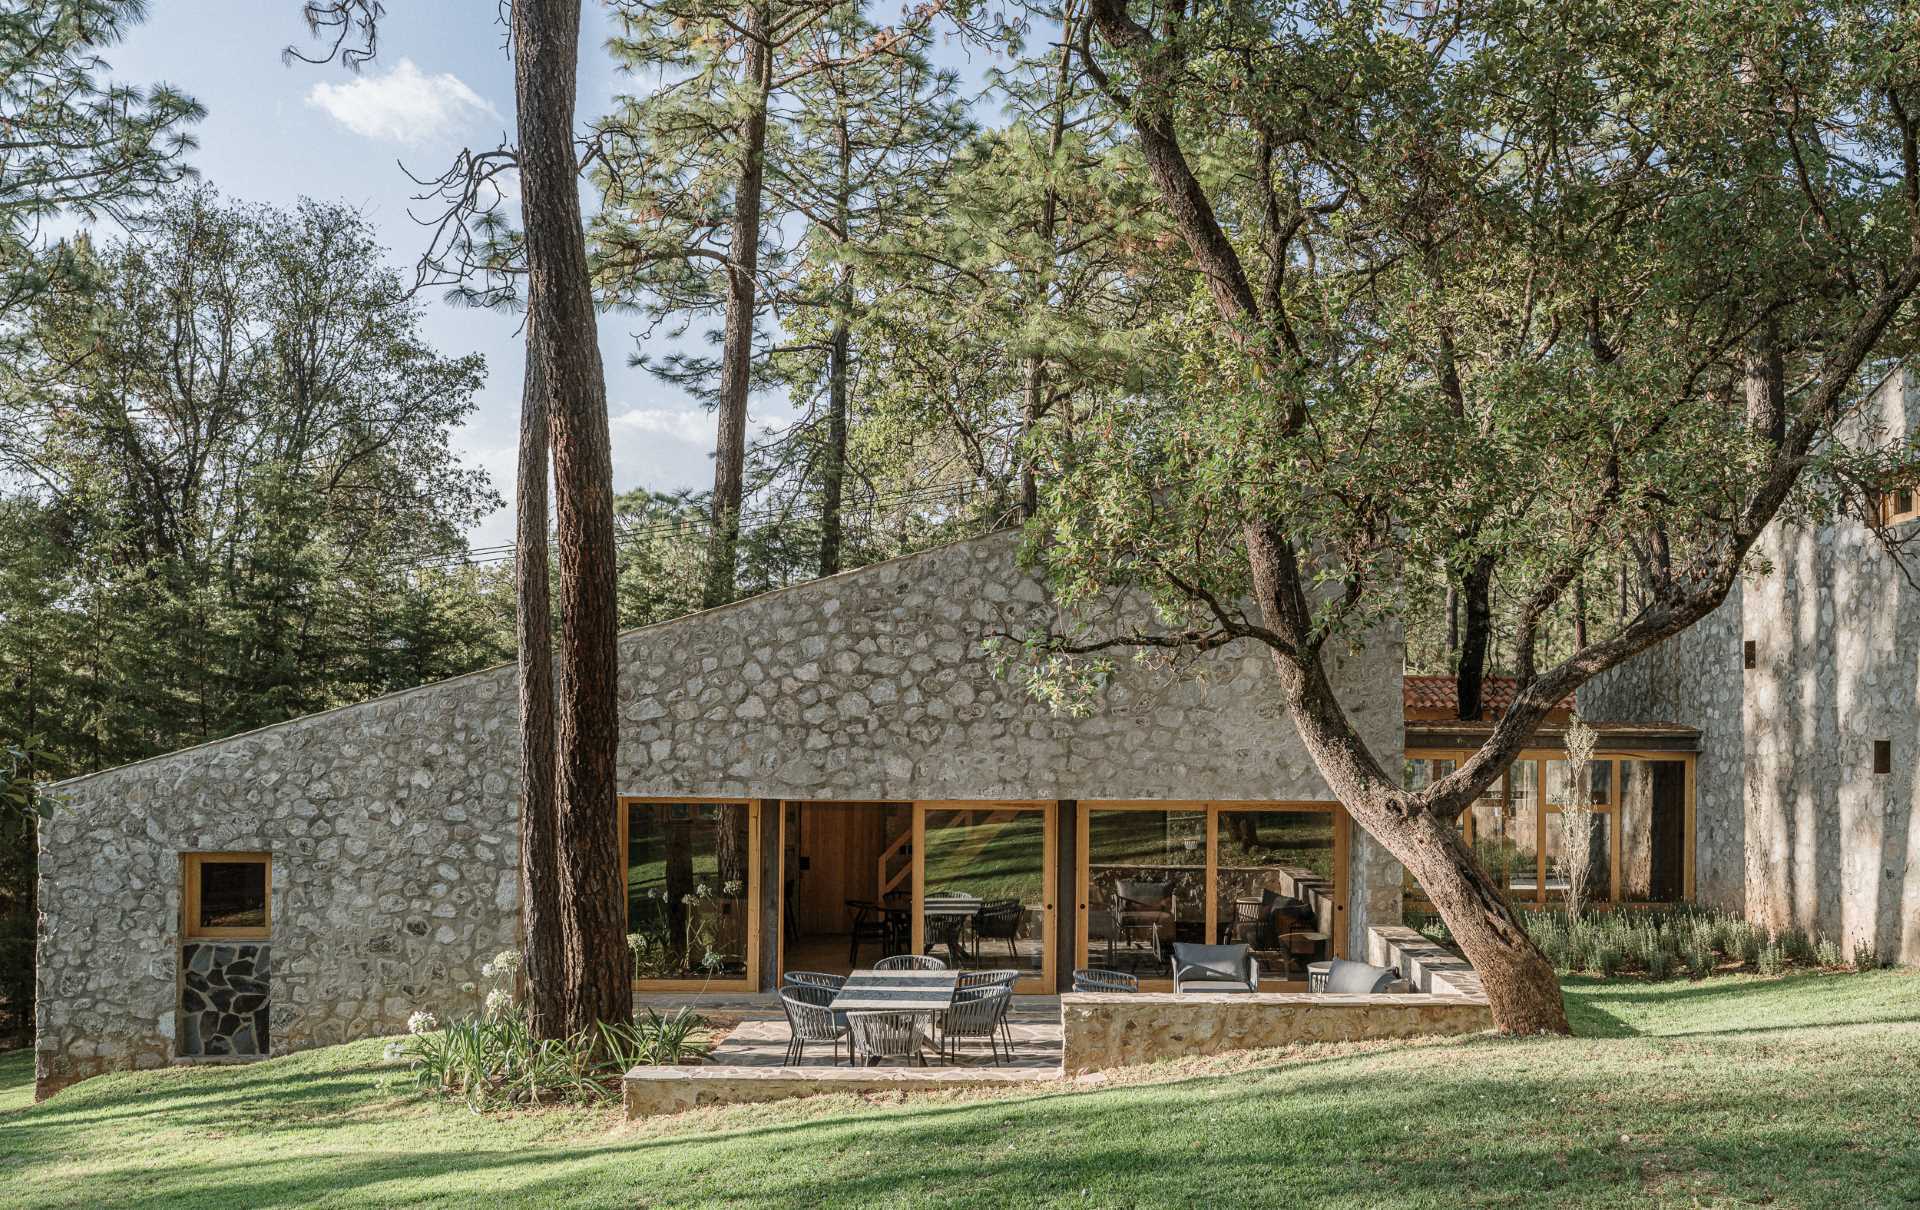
top-left (922, 805), bottom-right (1050, 978)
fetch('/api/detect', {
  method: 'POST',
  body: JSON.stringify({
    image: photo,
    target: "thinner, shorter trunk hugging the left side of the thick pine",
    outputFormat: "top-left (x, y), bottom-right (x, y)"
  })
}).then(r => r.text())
top-left (513, 311), bottom-right (566, 1037)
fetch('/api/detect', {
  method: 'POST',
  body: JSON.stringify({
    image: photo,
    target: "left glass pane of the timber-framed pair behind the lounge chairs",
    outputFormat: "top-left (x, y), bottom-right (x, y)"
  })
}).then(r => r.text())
top-left (1087, 807), bottom-right (1208, 978)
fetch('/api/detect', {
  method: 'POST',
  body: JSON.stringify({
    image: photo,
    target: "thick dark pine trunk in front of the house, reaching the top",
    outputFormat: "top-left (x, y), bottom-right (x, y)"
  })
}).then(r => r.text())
top-left (511, 0), bottom-right (634, 1029)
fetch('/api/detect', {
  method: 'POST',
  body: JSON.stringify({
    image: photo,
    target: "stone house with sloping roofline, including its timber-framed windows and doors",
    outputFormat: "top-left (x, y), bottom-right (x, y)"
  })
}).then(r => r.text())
top-left (36, 534), bottom-right (1404, 1095)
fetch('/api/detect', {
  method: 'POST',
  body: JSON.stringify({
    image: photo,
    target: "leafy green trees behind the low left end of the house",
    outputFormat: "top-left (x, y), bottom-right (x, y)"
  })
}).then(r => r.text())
top-left (0, 190), bottom-right (511, 778)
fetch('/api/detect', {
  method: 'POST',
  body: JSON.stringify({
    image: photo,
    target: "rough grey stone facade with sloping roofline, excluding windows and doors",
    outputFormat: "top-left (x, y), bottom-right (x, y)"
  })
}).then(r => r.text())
top-left (36, 534), bottom-right (1402, 1091)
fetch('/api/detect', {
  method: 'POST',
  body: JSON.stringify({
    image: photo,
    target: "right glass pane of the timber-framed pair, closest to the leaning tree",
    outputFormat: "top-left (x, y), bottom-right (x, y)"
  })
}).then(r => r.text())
top-left (1213, 809), bottom-right (1334, 980)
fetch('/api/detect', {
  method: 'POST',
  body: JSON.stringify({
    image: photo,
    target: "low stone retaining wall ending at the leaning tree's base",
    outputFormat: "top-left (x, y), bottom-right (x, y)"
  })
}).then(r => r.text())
top-left (1060, 991), bottom-right (1494, 1074)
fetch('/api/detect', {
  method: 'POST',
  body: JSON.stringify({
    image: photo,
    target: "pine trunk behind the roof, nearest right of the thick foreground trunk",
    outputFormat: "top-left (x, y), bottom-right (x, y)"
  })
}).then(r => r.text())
top-left (701, 4), bottom-right (774, 609)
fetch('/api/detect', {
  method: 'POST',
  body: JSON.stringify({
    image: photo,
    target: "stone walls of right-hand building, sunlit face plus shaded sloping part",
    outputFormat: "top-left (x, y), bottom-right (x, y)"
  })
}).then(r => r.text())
top-left (1580, 371), bottom-right (1920, 962)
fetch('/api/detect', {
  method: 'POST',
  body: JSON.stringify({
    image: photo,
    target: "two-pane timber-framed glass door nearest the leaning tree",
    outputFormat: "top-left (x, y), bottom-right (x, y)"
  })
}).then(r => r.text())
top-left (1075, 803), bottom-right (1348, 989)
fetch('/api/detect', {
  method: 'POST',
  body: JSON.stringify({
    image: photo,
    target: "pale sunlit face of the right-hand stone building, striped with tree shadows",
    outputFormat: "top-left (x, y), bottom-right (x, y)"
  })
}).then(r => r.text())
top-left (1745, 373), bottom-right (1920, 962)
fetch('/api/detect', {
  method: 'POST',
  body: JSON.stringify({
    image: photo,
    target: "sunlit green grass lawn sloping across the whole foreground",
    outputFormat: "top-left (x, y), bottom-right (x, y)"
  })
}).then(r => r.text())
top-left (0, 972), bottom-right (1920, 1210)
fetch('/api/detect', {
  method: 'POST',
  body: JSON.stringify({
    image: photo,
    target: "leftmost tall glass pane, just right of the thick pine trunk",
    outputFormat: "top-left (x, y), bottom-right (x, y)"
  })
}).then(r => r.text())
top-left (624, 801), bottom-right (753, 980)
